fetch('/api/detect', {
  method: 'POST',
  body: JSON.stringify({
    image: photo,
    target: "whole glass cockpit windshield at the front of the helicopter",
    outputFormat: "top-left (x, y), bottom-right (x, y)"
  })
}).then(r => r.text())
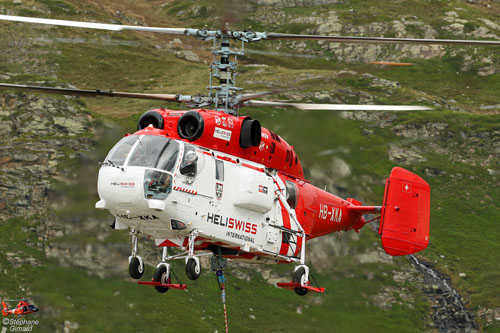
top-left (105, 135), bottom-right (179, 172)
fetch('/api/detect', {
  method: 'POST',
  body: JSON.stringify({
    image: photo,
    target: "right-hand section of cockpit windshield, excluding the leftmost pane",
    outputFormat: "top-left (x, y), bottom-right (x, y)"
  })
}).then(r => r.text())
top-left (128, 135), bottom-right (179, 172)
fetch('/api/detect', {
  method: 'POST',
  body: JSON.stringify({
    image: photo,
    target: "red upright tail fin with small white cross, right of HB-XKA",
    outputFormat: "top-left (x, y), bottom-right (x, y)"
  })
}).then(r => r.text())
top-left (379, 167), bottom-right (430, 256)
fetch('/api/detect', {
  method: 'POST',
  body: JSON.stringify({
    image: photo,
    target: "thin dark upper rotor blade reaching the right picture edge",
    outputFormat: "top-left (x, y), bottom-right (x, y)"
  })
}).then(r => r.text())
top-left (266, 32), bottom-right (500, 45)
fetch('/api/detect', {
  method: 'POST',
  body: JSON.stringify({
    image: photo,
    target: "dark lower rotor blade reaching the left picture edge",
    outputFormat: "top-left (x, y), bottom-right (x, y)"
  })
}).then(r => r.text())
top-left (0, 83), bottom-right (178, 102)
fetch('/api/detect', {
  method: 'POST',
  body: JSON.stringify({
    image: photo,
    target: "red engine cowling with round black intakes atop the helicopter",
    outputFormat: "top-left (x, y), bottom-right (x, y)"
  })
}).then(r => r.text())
top-left (136, 109), bottom-right (304, 179)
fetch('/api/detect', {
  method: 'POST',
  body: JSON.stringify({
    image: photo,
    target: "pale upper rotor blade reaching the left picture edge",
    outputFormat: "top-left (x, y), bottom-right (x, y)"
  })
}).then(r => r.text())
top-left (0, 15), bottom-right (188, 35)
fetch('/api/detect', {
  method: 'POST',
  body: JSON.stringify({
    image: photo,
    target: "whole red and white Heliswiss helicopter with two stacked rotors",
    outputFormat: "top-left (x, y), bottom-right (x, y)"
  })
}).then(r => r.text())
top-left (0, 15), bottom-right (500, 295)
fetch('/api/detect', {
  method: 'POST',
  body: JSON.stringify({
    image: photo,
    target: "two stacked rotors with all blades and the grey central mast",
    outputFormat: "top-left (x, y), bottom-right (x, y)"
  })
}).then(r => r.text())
top-left (0, 15), bottom-right (500, 115)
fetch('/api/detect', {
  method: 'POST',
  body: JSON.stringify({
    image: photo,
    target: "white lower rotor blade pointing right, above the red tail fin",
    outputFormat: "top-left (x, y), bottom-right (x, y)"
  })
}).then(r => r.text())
top-left (243, 100), bottom-right (432, 111)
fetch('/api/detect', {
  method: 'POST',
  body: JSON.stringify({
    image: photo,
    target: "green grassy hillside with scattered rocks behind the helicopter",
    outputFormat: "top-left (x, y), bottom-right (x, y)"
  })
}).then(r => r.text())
top-left (0, 0), bottom-right (500, 332)
